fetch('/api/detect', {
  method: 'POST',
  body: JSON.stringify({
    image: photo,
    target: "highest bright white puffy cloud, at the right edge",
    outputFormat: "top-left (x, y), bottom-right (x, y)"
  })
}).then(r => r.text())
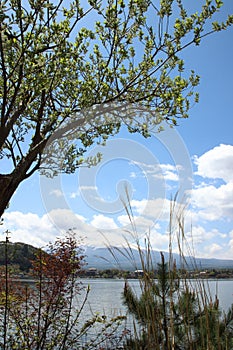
top-left (194, 144), bottom-right (233, 183)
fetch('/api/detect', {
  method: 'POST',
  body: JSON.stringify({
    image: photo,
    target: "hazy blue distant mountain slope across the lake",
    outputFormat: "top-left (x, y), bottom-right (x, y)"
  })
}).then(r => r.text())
top-left (84, 246), bottom-right (233, 271)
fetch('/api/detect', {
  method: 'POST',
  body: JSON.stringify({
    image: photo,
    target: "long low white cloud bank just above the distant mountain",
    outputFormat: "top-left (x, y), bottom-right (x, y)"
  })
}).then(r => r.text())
top-left (3, 205), bottom-right (233, 259)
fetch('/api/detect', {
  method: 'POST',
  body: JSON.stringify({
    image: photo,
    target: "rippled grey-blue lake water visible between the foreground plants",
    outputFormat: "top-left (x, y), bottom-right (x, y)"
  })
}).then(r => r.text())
top-left (73, 278), bottom-right (233, 349)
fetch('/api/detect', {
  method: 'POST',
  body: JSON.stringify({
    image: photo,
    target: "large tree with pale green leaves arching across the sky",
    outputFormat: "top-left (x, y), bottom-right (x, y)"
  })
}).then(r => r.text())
top-left (0, 0), bottom-right (233, 216)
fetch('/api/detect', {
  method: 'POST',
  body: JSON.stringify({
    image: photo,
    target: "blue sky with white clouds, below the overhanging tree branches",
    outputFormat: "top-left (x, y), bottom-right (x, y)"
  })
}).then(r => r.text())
top-left (1, 0), bottom-right (233, 259)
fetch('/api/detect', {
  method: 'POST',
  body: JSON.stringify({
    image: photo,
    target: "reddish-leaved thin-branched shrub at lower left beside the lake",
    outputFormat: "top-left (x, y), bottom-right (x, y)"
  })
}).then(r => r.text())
top-left (0, 230), bottom-right (125, 350)
